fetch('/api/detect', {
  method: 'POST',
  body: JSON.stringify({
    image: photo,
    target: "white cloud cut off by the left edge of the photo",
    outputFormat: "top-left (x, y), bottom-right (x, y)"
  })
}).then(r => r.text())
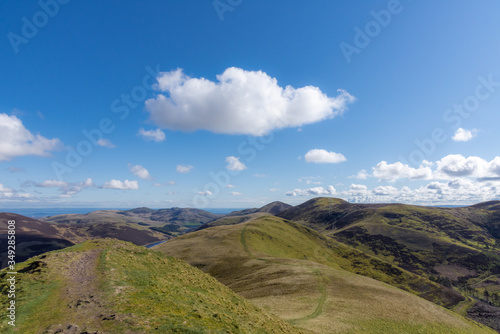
top-left (0, 113), bottom-right (62, 161)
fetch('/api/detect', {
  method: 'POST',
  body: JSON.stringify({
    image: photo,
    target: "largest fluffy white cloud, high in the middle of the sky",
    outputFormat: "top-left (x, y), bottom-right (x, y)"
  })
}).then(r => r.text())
top-left (146, 67), bottom-right (355, 136)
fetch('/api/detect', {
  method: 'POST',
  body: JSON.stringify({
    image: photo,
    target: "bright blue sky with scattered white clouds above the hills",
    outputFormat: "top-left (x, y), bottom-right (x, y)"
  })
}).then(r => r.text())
top-left (0, 0), bottom-right (500, 208)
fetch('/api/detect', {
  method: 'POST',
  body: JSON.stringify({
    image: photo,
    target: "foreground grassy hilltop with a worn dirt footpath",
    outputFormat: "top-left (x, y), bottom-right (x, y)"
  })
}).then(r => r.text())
top-left (0, 240), bottom-right (306, 334)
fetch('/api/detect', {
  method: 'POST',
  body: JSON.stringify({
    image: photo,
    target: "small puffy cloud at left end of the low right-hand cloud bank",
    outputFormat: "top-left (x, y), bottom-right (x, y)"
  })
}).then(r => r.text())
top-left (373, 161), bottom-right (432, 181)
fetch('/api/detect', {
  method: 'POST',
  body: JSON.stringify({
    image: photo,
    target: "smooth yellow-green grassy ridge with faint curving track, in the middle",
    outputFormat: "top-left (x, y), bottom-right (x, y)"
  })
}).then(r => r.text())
top-left (154, 216), bottom-right (494, 333)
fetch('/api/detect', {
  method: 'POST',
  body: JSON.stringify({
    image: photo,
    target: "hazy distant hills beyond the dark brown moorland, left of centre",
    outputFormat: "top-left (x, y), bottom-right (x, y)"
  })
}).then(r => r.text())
top-left (43, 208), bottom-right (222, 236)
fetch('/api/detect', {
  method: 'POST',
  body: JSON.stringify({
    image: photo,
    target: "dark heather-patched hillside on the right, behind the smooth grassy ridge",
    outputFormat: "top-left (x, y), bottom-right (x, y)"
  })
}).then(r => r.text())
top-left (279, 198), bottom-right (500, 330)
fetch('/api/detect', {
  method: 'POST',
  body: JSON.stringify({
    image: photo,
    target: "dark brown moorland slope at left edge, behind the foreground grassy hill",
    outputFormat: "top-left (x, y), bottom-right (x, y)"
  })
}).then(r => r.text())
top-left (0, 212), bottom-right (168, 268)
